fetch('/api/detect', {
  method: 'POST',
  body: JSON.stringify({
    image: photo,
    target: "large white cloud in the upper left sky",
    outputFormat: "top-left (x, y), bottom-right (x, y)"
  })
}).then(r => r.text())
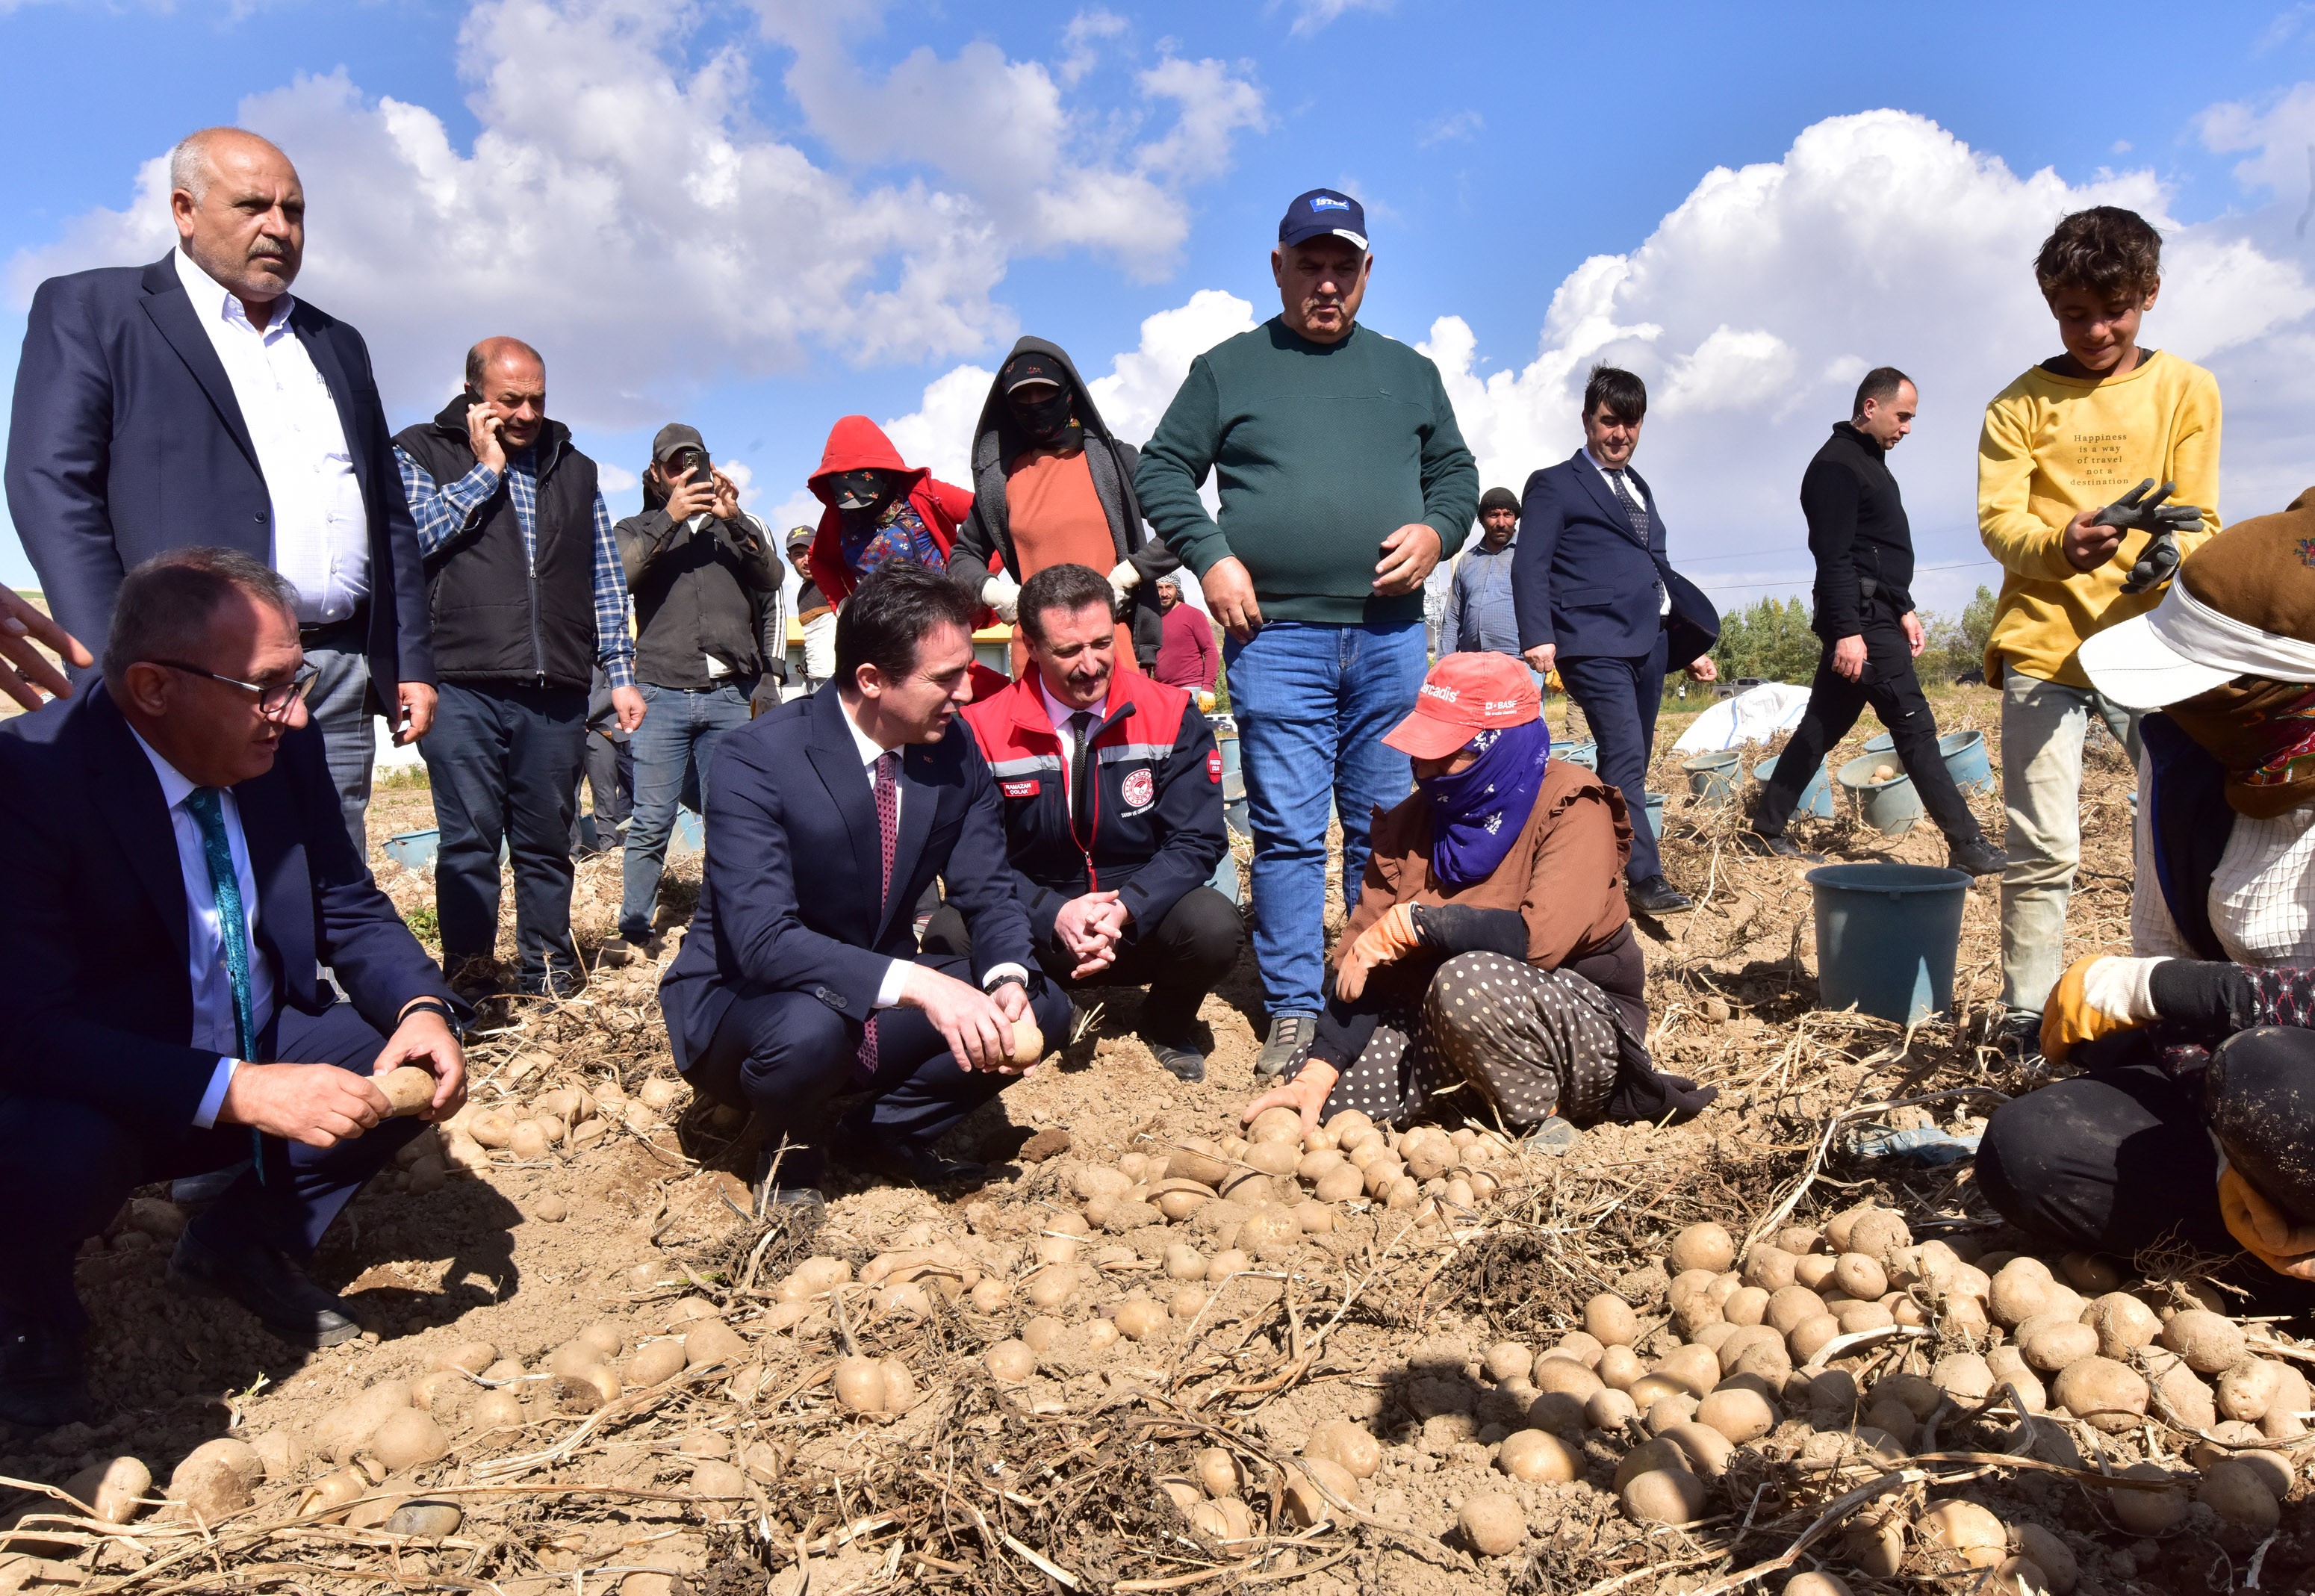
top-left (9, 0), bottom-right (1264, 426)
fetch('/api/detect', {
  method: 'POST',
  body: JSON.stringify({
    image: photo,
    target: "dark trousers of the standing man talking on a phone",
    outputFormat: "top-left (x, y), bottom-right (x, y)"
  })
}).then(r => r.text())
top-left (419, 681), bottom-right (585, 982)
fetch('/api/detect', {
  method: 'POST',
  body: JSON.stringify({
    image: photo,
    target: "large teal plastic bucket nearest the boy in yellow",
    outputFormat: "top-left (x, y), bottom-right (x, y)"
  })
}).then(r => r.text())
top-left (1808, 864), bottom-right (1970, 1026)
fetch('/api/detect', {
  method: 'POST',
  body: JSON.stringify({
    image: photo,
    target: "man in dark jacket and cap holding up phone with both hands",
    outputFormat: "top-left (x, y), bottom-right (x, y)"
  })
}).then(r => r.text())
top-left (602, 421), bottom-right (787, 963)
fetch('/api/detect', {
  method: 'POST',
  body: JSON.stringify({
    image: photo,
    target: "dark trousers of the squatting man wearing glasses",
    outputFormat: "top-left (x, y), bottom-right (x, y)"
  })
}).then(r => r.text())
top-left (0, 1003), bottom-right (423, 1335)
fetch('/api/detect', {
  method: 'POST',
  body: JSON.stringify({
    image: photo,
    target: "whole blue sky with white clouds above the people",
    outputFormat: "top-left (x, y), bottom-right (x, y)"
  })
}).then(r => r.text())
top-left (0, 0), bottom-right (2315, 609)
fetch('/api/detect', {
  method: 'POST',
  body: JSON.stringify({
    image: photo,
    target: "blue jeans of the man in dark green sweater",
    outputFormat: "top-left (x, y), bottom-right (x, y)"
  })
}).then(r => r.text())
top-left (1222, 621), bottom-right (1431, 1017)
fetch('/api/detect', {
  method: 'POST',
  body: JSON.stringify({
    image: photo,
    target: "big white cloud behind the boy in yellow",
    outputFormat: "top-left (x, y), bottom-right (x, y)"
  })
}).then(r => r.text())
top-left (1421, 105), bottom-right (2315, 607)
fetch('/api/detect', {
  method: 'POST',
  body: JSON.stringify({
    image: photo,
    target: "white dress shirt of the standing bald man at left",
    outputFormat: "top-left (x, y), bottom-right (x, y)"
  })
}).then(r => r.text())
top-left (176, 250), bottom-right (370, 625)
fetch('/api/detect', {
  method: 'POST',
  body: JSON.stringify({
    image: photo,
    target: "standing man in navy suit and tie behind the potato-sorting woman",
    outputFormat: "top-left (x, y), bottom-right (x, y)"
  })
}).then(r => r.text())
top-left (1511, 366), bottom-right (1720, 915)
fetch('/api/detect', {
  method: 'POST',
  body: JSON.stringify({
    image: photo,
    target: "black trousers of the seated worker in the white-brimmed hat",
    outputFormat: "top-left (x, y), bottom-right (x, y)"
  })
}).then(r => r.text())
top-left (1977, 1028), bottom-right (2315, 1311)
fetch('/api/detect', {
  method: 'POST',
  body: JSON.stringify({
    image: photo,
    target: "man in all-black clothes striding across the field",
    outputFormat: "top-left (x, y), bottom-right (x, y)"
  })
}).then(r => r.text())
top-left (1753, 366), bottom-right (2007, 875)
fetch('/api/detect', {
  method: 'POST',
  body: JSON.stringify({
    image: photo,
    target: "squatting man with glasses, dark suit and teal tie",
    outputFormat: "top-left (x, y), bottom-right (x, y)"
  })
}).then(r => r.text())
top-left (0, 549), bottom-right (465, 1429)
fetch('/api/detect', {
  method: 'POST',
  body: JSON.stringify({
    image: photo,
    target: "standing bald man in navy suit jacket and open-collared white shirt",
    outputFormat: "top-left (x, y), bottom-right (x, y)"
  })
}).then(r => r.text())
top-left (7, 128), bottom-right (435, 852)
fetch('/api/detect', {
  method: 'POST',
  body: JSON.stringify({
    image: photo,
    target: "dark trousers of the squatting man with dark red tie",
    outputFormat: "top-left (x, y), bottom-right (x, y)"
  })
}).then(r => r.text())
top-left (683, 954), bottom-right (1069, 1184)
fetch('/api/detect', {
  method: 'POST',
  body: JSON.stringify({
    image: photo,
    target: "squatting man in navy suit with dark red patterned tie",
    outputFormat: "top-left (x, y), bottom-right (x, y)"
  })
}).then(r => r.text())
top-left (660, 558), bottom-right (1069, 1202)
